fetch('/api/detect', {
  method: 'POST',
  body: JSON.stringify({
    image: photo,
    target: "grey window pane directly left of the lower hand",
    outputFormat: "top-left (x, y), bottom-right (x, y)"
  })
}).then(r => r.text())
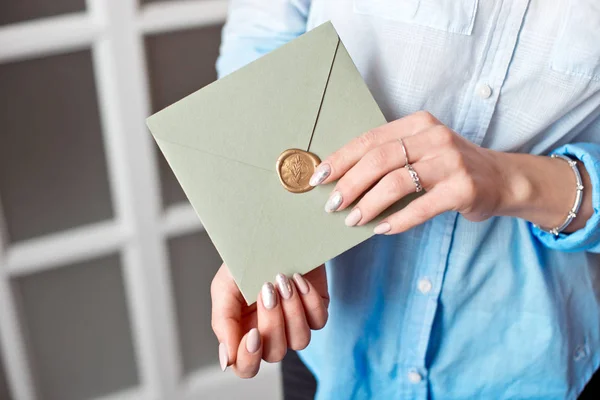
top-left (169, 232), bottom-right (221, 373)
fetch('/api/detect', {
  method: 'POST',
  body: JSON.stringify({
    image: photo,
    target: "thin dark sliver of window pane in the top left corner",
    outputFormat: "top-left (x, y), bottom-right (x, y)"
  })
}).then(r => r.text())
top-left (0, 0), bottom-right (85, 25)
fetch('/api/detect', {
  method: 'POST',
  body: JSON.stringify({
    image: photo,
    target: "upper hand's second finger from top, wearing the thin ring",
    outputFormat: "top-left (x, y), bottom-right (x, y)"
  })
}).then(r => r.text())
top-left (325, 138), bottom-right (440, 212)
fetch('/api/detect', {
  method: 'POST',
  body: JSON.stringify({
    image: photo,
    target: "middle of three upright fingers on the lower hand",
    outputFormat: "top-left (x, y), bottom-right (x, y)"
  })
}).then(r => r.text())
top-left (275, 274), bottom-right (310, 350)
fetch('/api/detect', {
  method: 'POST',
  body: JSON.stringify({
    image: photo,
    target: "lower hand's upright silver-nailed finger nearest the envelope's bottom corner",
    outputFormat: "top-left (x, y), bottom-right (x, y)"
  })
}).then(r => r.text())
top-left (257, 282), bottom-right (287, 362)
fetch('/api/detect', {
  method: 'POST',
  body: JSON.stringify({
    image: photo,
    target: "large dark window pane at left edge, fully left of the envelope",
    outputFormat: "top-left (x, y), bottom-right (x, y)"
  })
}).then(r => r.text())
top-left (0, 50), bottom-right (113, 241)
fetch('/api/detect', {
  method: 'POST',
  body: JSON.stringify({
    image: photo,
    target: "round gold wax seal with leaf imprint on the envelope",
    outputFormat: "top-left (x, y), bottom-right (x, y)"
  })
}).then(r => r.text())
top-left (277, 149), bottom-right (321, 193)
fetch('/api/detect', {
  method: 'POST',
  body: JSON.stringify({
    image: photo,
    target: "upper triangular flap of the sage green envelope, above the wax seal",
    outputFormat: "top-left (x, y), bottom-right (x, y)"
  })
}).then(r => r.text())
top-left (147, 22), bottom-right (339, 170)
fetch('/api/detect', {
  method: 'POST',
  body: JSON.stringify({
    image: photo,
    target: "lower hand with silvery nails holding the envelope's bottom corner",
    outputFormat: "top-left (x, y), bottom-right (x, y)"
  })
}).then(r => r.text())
top-left (211, 264), bottom-right (329, 378)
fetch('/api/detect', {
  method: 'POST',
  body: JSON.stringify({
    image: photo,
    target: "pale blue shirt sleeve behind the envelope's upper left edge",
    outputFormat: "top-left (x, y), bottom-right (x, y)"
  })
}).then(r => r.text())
top-left (217, 0), bottom-right (310, 78)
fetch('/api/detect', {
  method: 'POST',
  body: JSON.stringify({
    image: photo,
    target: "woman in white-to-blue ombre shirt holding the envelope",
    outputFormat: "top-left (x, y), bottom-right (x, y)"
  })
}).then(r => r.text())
top-left (212, 0), bottom-right (600, 399)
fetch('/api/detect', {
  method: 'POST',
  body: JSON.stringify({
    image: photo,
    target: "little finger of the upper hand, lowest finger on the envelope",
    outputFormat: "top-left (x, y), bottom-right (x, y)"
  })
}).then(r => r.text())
top-left (374, 185), bottom-right (454, 235)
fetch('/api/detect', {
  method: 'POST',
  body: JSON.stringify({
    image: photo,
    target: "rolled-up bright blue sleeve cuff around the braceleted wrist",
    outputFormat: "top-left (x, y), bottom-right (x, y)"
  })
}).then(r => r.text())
top-left (531, 143), bottom-right (600, 253)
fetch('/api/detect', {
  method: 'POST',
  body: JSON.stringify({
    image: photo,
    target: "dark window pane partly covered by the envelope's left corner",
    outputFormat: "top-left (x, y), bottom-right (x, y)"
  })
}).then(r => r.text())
top-left (146, 25), bottom-right (222, 206)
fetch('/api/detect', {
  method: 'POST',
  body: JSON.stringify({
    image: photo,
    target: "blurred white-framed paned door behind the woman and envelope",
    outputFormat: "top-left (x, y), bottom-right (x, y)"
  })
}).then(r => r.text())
top-left (0, 0), bottom-right (281, 400)
